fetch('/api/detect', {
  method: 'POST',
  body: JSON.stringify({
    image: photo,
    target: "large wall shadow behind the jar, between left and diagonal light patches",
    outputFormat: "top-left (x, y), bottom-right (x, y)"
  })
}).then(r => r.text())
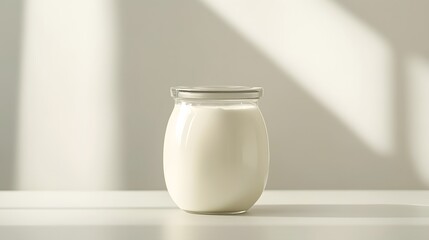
top-left (118, 0), bottom-right (425, 189)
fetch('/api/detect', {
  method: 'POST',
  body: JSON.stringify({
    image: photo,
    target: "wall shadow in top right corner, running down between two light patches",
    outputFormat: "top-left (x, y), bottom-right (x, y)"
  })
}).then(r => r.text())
top-left (336, 0), bottom-right (429, 189)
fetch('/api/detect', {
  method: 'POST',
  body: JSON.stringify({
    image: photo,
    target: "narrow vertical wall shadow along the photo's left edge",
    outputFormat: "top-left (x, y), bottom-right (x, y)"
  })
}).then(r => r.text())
top-left (0, 0), bottom-right (22, 190)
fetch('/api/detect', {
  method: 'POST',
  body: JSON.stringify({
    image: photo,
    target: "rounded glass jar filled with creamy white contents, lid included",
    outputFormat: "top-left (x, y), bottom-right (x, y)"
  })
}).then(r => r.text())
top-left (164, 86), bottom-right (269, 214)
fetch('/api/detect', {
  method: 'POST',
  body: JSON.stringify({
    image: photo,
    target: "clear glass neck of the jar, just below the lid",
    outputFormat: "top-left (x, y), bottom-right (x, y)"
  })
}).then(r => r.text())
top-left (174, 98), bottom-right (258, 106)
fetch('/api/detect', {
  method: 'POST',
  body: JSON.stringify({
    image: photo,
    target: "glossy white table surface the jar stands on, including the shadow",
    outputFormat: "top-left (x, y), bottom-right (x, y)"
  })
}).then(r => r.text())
top-left (0, 191), bottom-right (429, 240)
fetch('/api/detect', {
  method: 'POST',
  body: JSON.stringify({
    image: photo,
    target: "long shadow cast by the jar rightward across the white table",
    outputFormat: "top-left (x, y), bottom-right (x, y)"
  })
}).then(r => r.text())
top-left (244, 204), bottom-right (429, 218)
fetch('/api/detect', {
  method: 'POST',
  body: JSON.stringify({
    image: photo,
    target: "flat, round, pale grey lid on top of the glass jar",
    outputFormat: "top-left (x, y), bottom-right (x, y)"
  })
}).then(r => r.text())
top-left (171, 86), bottom-right (263, 99)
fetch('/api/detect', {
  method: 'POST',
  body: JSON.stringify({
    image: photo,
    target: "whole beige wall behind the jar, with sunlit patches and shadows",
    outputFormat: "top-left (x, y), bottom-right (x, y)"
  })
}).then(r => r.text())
top-left (0, 0), bottom-right (429, 190)
